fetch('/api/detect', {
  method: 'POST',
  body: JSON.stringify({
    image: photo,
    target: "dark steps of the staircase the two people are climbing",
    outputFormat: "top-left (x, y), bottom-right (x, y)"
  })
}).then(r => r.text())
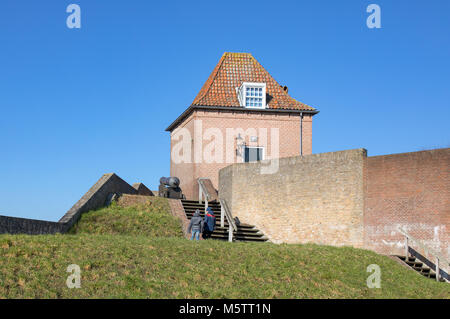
top-left (181, 199), bottom-right (268, 242)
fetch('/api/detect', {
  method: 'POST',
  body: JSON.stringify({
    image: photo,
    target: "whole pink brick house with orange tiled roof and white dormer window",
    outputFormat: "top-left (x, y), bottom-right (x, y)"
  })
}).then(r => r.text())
top-left (166, 53), bottom-right (318, 198)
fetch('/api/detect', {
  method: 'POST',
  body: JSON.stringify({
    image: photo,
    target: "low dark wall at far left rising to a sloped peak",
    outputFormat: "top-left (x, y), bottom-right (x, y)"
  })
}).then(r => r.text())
top-left (0, 173), bottom-right (138, 235)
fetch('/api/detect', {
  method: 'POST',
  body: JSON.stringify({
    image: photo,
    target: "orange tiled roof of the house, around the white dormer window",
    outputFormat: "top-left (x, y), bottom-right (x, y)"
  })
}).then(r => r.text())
top-left (192, 52), bottom-right (315, 111)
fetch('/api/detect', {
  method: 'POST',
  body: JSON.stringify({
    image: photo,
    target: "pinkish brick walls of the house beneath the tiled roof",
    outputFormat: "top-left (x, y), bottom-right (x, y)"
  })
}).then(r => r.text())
top-left (170, 110), bottom-right (312, 199)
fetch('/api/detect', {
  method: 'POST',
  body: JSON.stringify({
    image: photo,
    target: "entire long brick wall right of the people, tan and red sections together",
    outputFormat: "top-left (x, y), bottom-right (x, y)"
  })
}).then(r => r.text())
top-left (219, 148), bottom-right (450, 269)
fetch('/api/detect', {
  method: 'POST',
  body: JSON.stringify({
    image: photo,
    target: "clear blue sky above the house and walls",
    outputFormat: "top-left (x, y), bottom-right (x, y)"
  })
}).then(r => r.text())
top-left (0, 0), bottom-right (450, 220)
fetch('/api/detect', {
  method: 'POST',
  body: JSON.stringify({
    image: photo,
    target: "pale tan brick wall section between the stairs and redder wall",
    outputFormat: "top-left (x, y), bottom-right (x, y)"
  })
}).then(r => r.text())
top-left (219, 149), bottom-right (366, 247)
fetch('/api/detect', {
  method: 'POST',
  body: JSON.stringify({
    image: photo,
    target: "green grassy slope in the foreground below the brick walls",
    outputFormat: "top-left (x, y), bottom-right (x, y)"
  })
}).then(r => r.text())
top-left (0, 202), bottom-right (450, 298)
